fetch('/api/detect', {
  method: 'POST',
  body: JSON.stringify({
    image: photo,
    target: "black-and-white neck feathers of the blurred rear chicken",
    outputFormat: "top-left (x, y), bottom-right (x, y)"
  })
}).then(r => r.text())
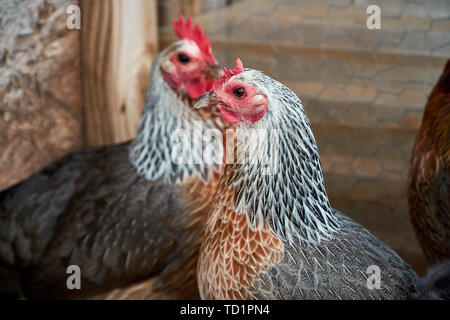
top-left (130, 48), bottom-right (222, 184)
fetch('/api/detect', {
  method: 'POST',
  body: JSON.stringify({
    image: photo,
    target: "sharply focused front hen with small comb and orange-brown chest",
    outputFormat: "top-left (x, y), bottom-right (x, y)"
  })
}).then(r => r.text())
top-left (197, 60), bottom-right (450, 299)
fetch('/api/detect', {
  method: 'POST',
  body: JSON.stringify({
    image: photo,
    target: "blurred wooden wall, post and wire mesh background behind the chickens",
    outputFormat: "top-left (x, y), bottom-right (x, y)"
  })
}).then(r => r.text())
top-left (0, 0), bottom-right (450, 274)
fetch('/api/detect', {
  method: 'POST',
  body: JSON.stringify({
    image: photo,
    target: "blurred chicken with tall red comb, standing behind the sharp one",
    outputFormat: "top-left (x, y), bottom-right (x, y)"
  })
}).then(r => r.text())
top-left (0, 16), bottom-right (222, 299)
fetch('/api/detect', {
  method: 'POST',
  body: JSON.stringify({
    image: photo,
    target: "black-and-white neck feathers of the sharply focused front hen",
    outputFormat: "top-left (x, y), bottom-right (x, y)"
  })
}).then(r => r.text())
top-left (217, 72), bottom-right (337, 242)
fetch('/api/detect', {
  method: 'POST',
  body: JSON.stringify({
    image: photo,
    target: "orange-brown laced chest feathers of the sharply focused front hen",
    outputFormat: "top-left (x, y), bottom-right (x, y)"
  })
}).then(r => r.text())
top-left (197, 186), bottom-right (283, 300)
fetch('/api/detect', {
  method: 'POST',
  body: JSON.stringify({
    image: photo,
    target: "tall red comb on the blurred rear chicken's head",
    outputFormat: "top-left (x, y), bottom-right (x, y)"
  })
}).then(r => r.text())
top-left (172, 13), bottom-right (216, 63)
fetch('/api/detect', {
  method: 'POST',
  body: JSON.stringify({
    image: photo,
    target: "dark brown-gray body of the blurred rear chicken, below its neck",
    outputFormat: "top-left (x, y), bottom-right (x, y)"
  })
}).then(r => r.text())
top-left (0, 142), bottom-right (204, 298)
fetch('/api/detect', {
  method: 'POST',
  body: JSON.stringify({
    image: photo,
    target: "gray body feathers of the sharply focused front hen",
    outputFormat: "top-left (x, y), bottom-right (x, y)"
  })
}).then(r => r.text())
top-left (251, 213), bottom-right (421, 299)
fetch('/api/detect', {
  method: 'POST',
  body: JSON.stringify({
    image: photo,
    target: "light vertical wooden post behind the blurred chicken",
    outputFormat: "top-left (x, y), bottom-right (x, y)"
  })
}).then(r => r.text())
top-left (81, 0), bottom-right (158, 146)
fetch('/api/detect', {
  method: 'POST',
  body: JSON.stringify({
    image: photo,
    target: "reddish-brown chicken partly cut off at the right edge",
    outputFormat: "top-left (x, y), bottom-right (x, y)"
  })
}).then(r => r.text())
top-left (408, 60), bottom-right (450, 264)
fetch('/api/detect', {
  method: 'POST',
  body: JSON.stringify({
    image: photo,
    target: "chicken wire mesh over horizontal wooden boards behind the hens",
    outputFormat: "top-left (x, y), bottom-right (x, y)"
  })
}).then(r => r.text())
top-left (159, 0), bottom-right (450, 271)
